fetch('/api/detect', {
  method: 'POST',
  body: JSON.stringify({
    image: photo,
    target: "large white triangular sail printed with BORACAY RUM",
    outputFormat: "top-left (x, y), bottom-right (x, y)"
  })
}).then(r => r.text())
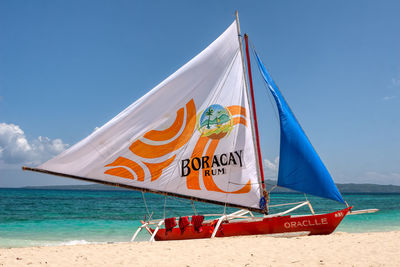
top-left (38, 22), bottom-right (261, 208)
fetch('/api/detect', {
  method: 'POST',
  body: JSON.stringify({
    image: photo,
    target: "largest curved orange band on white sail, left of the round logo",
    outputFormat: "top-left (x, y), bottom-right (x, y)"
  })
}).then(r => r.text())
top-left (129, 99), bottom-right (196, 159)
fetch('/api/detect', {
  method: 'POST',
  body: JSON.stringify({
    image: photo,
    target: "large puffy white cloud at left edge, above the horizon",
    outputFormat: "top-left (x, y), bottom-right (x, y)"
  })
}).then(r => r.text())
top-left (0, 123), bottom-right (69, 168)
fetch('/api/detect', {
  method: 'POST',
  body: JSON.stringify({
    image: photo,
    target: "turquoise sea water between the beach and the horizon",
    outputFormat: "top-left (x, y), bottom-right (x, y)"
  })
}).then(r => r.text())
top-left (0, 189), bottom-right (400, 247)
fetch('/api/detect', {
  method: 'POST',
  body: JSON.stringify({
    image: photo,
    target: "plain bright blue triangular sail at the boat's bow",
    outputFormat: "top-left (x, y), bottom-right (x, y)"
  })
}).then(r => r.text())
top-left (255, 53), bottom-right (345, 204)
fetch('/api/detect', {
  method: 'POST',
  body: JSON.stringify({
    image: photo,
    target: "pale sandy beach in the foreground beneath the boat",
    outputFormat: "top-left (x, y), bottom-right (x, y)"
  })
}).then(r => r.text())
top-left (0, 231), bottom-right (400, 266)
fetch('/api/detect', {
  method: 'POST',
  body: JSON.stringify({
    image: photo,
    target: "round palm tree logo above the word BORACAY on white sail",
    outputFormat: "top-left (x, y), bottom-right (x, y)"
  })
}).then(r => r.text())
top-left (197, 104), bottom-right (233, 139)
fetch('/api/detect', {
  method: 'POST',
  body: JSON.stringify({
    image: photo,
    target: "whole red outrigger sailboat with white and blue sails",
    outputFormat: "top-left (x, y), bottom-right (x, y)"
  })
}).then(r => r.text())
top-left (23, 13), bottom-right (378, 241)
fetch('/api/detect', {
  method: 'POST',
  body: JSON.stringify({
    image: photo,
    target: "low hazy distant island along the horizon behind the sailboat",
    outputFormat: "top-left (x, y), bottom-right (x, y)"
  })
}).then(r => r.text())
top-left (22, 180), bottom-right (400, 194)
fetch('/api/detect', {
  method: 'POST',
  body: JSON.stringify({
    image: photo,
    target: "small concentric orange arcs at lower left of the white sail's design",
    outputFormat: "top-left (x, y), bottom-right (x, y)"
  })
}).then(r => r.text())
top-left (104, 157), bottom-right (144, 181)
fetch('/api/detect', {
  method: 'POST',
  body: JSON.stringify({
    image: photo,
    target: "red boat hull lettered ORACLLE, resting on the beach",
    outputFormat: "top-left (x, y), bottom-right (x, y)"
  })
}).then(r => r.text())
top-left (147, 207), bottom-right (351, 241)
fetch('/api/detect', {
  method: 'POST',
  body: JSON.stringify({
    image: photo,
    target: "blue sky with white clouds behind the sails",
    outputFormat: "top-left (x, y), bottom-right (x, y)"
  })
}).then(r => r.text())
top-left (0, 0), bottom-right (400, 187)
